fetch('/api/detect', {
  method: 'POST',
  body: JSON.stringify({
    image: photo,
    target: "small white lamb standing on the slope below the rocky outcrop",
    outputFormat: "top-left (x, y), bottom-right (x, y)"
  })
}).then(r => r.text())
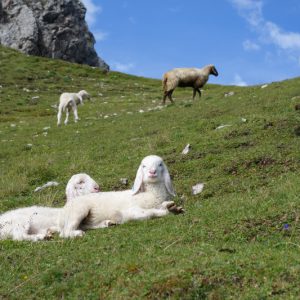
top-left (57, 90), bottom-right (90, 126)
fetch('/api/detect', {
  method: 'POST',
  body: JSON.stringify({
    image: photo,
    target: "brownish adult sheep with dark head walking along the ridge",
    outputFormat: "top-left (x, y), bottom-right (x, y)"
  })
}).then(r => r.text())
top-left (162, 65), bottom-right (219, 104)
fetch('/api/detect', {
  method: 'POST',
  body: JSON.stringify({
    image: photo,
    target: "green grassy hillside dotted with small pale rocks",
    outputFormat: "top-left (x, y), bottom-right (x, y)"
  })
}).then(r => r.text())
top-left (0, 48), bottom-right (300, 299)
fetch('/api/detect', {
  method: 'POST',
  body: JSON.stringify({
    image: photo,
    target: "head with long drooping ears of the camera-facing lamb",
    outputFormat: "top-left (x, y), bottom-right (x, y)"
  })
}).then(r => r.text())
top-left (133, 155), bottom-right (175, 196)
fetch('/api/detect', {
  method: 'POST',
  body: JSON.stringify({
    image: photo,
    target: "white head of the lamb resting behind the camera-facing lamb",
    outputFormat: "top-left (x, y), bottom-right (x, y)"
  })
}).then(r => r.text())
top-left (66, 173), bottom-right (100, 201)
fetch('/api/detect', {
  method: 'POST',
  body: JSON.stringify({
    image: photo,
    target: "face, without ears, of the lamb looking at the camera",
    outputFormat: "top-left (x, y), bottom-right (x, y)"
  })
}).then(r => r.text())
top-left (141, 155), bottom-right (166, 183)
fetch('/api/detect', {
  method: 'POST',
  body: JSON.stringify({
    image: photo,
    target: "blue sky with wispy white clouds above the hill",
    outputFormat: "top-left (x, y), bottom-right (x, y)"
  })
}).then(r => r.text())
top-left (82, 0), bottom-right (300, 85)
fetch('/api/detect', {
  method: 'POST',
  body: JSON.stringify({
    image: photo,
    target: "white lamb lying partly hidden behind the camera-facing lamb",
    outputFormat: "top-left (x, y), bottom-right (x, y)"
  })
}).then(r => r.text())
top-left (0, 174), bottom-right (100, 241)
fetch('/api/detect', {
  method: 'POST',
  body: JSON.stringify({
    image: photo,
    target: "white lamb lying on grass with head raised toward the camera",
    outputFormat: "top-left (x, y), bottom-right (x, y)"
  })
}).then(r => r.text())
top-left (59, 155), bottom-right (183, 238)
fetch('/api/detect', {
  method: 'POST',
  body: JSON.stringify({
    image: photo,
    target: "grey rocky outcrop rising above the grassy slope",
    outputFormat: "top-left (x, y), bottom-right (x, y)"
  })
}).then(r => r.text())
top-left (0, 0), bottom-right (109, 70)
